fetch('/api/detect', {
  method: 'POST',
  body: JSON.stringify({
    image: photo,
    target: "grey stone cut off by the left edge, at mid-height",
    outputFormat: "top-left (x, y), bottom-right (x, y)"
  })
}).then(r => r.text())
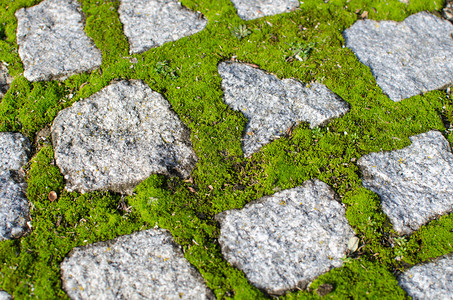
top-left (0, 132), bottom-right (30, 241)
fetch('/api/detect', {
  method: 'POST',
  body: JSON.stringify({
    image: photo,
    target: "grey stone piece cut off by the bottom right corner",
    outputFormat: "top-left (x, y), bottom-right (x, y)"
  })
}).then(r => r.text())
top-left (398, 255), bottom-right (453, 299)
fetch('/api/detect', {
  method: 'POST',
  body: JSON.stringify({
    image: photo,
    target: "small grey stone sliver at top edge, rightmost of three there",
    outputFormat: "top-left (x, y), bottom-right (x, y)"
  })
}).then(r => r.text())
top-left (231, 0), bottom-right (299, 20)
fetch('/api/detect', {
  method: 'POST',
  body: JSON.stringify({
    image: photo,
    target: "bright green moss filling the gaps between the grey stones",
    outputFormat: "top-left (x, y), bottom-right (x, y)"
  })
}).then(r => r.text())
top-left (0, 0), bottom-right (453, 299)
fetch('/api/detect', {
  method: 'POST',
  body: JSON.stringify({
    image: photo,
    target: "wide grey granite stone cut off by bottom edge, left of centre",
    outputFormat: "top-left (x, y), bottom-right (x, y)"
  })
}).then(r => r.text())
top-left (61, 229), bottom-right (214, 299)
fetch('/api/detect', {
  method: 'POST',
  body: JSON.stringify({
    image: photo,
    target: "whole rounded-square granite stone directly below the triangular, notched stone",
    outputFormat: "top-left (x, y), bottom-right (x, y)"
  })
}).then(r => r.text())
top-left (216, 179), bottom-right (354, 295)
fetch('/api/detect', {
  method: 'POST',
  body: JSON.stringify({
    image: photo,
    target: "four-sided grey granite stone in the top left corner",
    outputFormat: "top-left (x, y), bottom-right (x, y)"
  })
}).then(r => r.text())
top-left (16, 0), bottom-right (102, 81)
